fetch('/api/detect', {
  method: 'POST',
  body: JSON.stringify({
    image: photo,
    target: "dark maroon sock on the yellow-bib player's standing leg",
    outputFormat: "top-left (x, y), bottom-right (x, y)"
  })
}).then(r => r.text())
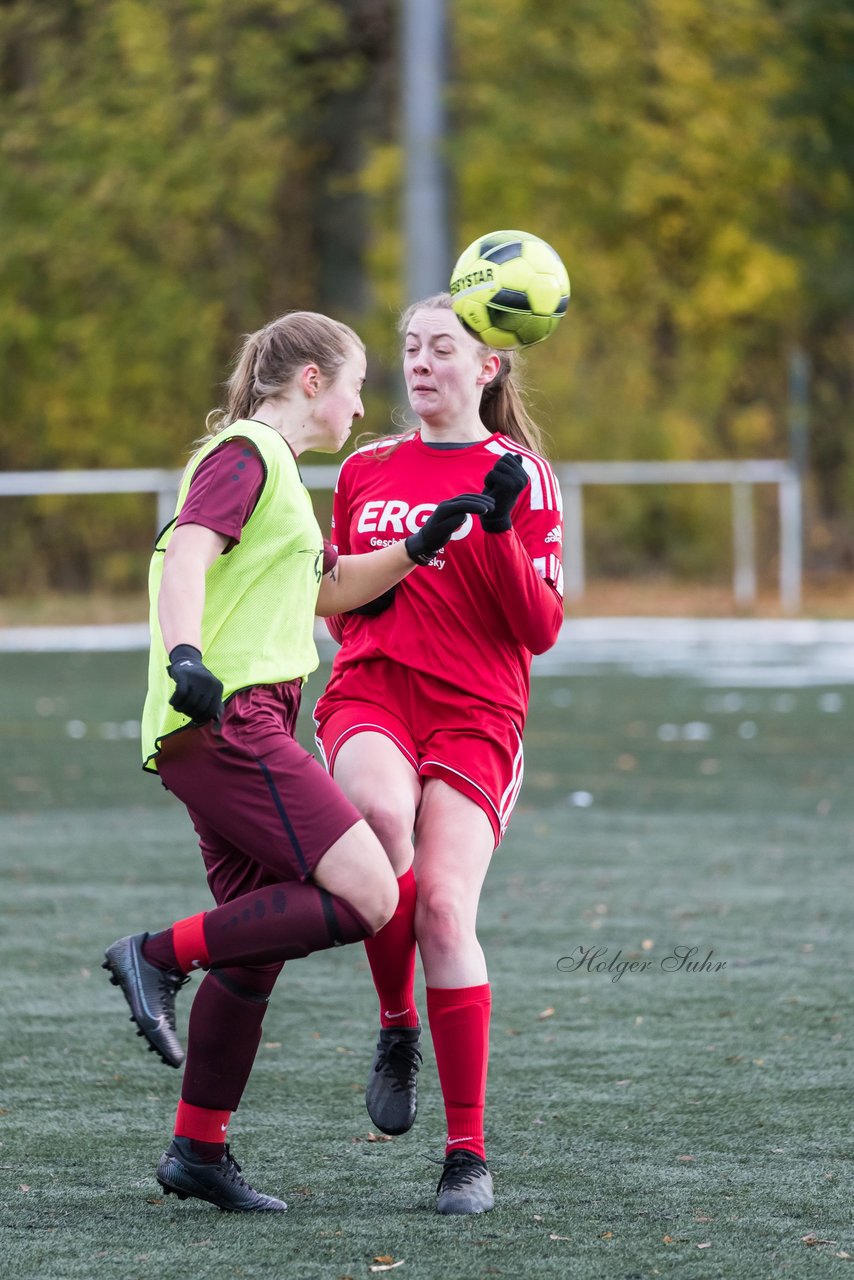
top-left (181, 964), bottom-right (282, 1111)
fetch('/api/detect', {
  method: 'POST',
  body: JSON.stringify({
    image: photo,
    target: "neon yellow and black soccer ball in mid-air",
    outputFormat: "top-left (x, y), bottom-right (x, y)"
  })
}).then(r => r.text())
top-left (451, 230), bottom-right (570, 348)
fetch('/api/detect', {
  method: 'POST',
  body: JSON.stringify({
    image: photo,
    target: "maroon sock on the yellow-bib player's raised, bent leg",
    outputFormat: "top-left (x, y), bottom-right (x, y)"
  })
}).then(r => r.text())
top-left (204, 881), bottom-right (373, 969)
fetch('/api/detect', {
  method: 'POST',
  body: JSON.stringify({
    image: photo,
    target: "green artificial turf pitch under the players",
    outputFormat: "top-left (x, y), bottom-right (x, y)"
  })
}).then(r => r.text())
top-left (0, 655), bottom-right (854, 1280)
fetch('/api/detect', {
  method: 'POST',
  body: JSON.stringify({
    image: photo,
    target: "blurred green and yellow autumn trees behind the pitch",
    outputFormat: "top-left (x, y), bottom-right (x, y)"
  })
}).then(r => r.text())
top-left (0, 0), bottom-right (854, 591)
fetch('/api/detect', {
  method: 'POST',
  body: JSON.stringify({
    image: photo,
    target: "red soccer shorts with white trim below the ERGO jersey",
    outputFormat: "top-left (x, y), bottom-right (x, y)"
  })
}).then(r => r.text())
top-left (315, 658), bottom-right (524, 845)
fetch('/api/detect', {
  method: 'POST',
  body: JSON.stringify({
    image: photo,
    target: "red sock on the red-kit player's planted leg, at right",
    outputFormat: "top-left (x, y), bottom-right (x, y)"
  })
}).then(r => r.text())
top-left (426, 983), bottom-right (492, 1160)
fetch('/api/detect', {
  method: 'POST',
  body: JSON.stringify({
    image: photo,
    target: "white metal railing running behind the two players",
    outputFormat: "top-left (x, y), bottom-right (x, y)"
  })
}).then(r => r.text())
top-left (0, 461), bottom-right (803, 613)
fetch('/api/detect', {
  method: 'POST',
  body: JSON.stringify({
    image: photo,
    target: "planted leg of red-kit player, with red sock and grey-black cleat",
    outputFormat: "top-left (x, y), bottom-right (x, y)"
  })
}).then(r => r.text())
top-left (415, 778), bottom-right (494, 1213)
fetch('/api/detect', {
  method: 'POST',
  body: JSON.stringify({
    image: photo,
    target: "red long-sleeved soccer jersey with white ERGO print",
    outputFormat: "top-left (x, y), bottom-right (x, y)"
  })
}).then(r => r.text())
top-left (328, 434), bottom-right (563, 730)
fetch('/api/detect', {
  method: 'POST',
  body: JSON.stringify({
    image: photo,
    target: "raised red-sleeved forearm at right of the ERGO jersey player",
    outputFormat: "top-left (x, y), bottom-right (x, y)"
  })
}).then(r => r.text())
top-left (484, 529), bottom-right (563, 653)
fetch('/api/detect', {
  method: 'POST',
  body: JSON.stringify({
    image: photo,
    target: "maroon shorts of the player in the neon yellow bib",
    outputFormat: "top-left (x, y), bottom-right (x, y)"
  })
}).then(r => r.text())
top-left (157, 681), bottom-right (361, 902)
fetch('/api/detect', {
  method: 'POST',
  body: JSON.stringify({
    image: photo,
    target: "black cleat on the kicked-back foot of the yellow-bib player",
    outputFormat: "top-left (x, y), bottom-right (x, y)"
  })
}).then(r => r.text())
top-left (101, 933), bottom-right (189, 1066)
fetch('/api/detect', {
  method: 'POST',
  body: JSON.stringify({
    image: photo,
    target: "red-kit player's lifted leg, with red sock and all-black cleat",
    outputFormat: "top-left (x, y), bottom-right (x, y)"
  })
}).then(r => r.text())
top-left (334, 732), bottom-right (421, 1134)
